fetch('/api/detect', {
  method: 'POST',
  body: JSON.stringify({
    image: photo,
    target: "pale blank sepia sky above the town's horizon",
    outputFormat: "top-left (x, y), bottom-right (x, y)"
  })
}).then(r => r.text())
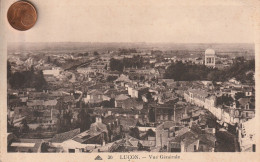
top-left (4, 0), bottom-right (254, 43)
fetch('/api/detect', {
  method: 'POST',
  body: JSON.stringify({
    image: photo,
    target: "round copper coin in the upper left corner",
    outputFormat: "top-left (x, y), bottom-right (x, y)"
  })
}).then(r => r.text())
top-left (7, 1), bottom-right (37, 31)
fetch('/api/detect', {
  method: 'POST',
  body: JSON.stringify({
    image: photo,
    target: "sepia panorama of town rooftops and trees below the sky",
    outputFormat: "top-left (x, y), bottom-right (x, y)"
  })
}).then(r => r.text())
top-left (7, 42), bottom-right (256, 153)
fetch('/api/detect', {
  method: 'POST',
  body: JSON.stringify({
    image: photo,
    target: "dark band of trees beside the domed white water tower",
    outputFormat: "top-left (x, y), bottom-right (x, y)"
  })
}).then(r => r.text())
top-left (164, 57), bottom-right (255, 83)
